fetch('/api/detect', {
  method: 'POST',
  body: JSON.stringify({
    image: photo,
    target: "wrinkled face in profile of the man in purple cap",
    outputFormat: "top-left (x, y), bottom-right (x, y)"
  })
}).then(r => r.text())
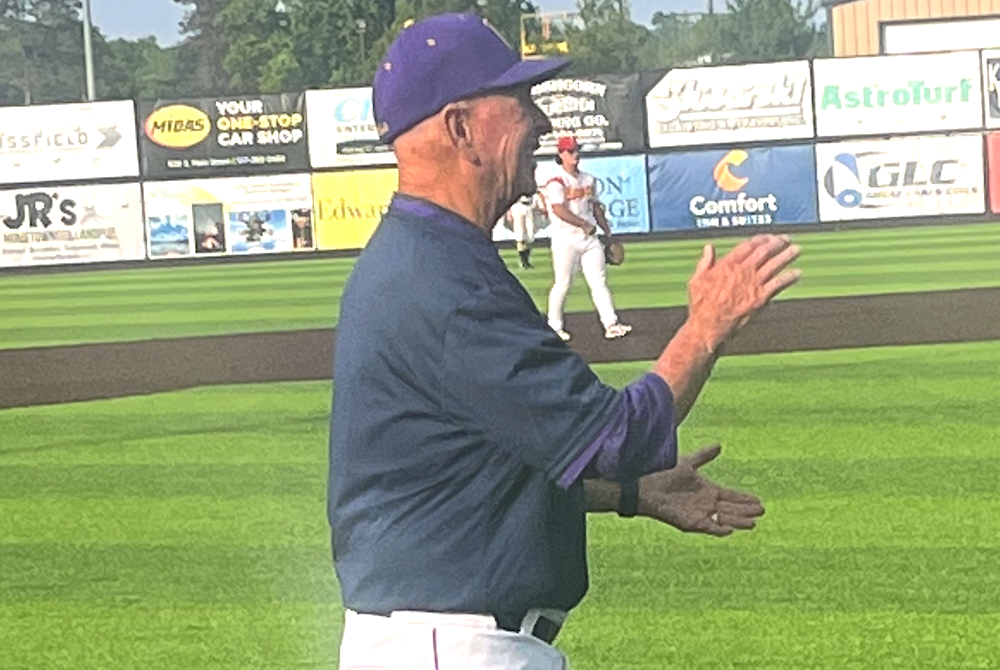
top-left (475, 86), bottom-right (552, 208)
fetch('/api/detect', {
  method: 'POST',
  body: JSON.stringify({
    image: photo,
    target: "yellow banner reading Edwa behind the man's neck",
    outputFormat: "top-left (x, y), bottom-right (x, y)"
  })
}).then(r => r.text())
top-left (312, 168), bottom-right (399, 250)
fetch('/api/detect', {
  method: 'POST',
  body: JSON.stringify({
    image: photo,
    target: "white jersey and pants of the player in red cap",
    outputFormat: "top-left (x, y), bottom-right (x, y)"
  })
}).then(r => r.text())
top-left (545, 166), bottom-right (618, 331)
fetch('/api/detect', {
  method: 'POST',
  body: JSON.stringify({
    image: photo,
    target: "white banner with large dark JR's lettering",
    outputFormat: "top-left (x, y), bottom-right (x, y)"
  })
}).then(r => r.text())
top-left (0, 184), bottom-right (146, 267)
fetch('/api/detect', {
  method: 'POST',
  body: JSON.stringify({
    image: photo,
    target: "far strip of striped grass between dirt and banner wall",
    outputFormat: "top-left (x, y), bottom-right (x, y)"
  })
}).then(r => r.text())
top-left (0, 224), bottom-right (1000, 349)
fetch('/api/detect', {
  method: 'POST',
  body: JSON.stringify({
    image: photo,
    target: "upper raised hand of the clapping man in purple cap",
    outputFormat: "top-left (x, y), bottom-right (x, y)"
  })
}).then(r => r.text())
top-left (688, 235), bottom-right (802, 351)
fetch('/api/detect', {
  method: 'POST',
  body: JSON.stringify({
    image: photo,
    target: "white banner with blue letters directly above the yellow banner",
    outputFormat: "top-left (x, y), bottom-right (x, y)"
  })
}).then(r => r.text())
top-left (306, 86), bottom-right (396, 169)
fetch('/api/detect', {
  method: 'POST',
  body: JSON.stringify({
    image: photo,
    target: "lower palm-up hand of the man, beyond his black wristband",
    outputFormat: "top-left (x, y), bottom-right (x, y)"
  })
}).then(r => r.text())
top-left (639, 444), bottom-right (764, 537)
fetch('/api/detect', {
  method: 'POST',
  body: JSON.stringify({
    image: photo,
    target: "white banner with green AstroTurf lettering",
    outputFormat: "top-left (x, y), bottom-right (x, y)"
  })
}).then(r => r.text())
top-left (813, 51), bottom-right (983, 137)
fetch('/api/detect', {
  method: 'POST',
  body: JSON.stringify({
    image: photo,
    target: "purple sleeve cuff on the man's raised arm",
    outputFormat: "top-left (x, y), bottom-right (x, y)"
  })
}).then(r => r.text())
top-left (558, 373), bottom-right (677, 489)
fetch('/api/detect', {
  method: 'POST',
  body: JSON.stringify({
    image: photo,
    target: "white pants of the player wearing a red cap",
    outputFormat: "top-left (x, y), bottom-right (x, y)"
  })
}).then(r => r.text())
top-left (549, 234), bottom-right (618, 330)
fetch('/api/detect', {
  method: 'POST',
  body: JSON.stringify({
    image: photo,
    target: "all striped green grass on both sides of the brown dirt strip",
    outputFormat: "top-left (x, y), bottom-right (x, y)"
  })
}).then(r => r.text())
top-left (0, 225), bottom-right (1000, 670)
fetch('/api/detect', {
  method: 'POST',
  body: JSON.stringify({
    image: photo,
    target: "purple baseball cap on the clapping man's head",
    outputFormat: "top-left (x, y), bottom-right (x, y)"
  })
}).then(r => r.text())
top-left (372, 14), bottom-right (570, 143)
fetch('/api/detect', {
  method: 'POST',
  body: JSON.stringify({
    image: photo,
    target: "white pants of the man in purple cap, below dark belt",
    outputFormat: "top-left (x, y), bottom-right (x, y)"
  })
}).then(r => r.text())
top-left (340, 610), bottom-right (569, 670)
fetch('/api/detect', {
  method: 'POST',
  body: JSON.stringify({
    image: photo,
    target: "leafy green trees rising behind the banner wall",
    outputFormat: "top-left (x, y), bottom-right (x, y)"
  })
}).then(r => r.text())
top-left (0, 0), bottom-right (826, 105)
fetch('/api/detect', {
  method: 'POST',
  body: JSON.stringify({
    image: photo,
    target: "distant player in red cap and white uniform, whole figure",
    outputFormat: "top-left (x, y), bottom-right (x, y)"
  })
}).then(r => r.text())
top-left (545, 137), bottom-right (632, 340)
